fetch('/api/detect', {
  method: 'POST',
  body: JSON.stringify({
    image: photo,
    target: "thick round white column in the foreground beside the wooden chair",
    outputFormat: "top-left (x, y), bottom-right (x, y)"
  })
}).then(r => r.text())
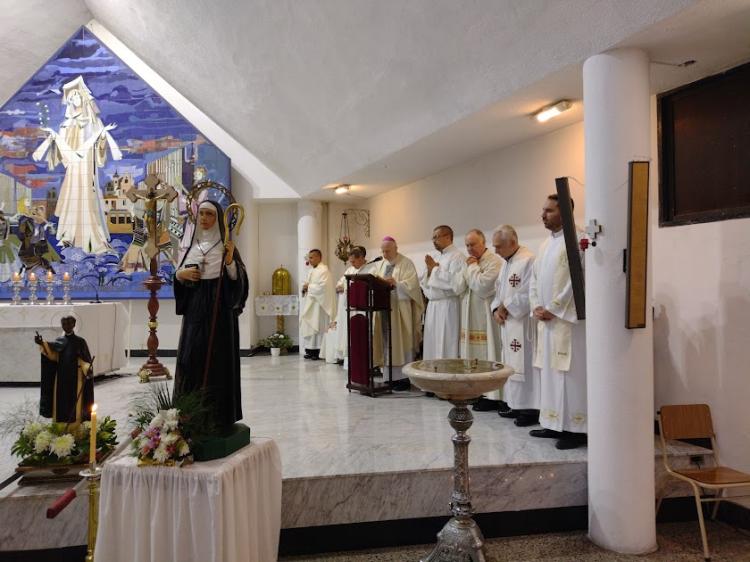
top-left (583, 49), bottom-right (656, 554)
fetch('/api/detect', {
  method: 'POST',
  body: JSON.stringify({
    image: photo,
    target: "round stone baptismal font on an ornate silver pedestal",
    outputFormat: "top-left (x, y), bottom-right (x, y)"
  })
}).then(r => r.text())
top-left (404, 359), bottom-right (513, 562)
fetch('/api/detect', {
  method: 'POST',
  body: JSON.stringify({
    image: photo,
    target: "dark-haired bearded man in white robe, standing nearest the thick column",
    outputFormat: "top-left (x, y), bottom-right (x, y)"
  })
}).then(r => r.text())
top-left (529, 194), bottom-right (587, 449)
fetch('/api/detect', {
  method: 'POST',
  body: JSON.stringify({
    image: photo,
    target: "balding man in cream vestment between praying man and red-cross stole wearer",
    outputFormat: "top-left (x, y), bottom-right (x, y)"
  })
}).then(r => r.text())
top-left (456, 228), bottom-right (507, 406)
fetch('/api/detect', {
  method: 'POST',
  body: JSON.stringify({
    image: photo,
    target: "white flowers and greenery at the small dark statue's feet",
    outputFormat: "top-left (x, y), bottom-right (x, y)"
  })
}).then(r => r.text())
top-left (11, 416), bottom-right (117, 467)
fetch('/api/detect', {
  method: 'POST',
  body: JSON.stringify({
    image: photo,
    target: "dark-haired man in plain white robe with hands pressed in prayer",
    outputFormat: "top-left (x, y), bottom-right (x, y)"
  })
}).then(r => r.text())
top-left (419, 225), bottom-right (466, 359)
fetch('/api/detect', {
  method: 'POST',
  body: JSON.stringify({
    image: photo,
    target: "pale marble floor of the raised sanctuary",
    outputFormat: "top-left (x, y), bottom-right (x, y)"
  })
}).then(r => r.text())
top-left (0, 355), bottom-right (704, 479)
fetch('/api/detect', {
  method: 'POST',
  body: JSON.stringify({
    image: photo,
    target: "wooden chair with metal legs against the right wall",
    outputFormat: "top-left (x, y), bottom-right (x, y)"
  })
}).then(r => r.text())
top-left (656, 404), bottom-right (750, 560)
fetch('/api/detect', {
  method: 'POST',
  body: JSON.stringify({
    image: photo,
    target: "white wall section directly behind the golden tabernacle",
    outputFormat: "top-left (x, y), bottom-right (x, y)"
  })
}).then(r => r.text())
top-left (253, 203), bottom-right (299, 344)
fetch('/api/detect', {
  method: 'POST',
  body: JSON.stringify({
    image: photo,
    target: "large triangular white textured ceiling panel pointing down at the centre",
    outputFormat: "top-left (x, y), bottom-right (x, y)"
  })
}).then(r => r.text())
top-left (82, 0), bottom-right (695, 194)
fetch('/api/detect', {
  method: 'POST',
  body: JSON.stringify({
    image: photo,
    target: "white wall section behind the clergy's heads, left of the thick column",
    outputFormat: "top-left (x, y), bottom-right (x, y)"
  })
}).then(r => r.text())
top-left (368, 123), bottom-right (584, 269)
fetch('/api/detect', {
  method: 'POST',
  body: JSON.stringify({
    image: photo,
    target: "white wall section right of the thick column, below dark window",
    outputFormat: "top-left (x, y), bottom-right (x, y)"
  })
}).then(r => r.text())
top-left (651, 101), bottom-right (750, 474)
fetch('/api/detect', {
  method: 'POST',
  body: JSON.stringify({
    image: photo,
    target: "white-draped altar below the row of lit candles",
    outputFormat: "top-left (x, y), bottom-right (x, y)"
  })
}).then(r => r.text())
top-left (0, 302), bottom-right (128, 382)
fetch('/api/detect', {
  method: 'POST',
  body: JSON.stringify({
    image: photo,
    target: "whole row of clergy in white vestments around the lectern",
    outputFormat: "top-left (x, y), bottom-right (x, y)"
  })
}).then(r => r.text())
top-left (300, 195), bottom-right (587, 449)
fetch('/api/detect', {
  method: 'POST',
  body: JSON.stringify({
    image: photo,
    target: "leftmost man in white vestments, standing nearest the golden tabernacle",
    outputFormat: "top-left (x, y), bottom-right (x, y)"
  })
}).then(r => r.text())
top-left (299, 249), bottom-right (336, 359)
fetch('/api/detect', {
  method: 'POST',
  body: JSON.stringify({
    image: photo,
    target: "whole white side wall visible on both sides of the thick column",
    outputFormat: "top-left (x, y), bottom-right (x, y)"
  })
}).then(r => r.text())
top-left (368, 114), bottom-right (750, 471)
